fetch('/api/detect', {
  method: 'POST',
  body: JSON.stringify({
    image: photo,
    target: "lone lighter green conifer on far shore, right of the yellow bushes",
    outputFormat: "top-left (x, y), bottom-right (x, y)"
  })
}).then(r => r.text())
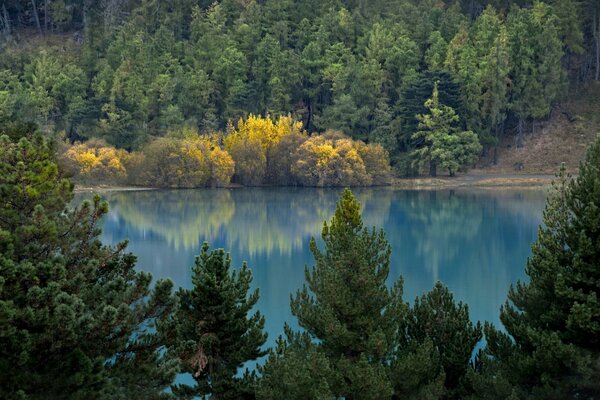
top-left (412, 83), bottom-right (481, 177)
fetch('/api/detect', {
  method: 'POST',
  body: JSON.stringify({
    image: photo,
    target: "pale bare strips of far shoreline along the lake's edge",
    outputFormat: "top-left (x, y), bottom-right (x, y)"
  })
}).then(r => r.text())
top-left (74, 174), bottom-right (555, 193)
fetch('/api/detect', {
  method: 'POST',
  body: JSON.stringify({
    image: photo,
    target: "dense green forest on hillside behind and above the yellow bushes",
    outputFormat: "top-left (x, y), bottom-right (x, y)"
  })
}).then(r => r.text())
top-left (0, 0), bottom-right (584, 174)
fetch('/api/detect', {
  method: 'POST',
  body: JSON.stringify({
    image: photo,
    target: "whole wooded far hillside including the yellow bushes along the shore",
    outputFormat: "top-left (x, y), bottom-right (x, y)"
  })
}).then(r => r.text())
top-left (0, 0), bottom-right (600, 187)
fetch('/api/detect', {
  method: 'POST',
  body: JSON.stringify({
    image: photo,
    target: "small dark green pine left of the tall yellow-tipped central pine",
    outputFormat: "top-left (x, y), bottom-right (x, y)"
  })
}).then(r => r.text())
top-left (163, 242), bottom-right (267, 400)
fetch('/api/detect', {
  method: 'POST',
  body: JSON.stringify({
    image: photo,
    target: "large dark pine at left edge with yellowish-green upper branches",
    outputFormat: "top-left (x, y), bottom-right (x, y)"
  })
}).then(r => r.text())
top-left (0, 136), bottom-right (176, 399)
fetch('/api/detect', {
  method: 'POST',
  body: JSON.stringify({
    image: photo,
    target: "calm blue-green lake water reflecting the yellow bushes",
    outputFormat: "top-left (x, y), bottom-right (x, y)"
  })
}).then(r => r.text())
top-left (76, 188), bottom-right (546, 354)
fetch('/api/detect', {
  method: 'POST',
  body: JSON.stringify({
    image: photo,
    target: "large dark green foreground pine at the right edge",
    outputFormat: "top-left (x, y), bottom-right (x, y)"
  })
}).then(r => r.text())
top-left (477, 138), bottom-right (600, 399)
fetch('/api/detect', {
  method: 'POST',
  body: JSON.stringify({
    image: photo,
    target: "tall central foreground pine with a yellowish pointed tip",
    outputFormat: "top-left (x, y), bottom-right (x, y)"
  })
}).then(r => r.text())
top-left (291, 189), bottom-right (405, 399)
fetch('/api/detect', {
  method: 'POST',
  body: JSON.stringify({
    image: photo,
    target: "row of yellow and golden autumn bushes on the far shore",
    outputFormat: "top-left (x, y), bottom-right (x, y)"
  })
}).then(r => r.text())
top-left (64, 115), bottom-right (391, 188)
